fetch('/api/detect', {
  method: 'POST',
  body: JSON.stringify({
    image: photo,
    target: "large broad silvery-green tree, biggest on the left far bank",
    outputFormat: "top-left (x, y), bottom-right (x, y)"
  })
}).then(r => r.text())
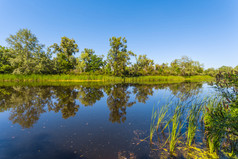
top-left (6, 29), bottom-right (47, 74)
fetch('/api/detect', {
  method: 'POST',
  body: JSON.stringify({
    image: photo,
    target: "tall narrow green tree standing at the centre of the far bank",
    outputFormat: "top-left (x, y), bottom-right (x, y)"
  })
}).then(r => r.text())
top-left (107, 37), bottom-right (135, 76)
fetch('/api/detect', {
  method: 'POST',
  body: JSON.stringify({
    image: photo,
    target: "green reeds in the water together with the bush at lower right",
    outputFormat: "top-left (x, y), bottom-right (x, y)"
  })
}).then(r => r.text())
top-left (151, 71), bottom-right (238, 158)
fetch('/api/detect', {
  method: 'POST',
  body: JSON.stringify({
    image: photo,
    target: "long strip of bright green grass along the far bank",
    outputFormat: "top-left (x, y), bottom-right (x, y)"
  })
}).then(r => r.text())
top-left (0, 74), bottom-right (213, 83)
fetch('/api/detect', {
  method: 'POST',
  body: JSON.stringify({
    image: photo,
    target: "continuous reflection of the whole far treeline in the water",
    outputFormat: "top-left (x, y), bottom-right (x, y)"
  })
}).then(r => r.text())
top-left (0, 83), bottom-right (202, 128)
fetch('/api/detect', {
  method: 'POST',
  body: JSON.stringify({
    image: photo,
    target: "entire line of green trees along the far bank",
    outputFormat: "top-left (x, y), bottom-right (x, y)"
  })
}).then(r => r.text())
top-left (0, 29), bottom-right (238, 77)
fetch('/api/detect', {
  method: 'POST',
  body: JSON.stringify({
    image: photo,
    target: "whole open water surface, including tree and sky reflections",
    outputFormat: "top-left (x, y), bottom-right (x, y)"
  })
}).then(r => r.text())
top-left (0, 83), bottom-right (213, 159)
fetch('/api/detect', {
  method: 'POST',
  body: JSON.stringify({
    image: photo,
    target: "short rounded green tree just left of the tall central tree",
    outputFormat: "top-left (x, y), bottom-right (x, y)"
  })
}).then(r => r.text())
top-left (78, 48), bottom-right (105, 72)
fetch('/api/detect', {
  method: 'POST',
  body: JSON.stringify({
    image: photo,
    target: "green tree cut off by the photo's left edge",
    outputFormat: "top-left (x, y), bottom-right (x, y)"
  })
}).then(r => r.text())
top-left (0, 46), bottom-right (12, 73)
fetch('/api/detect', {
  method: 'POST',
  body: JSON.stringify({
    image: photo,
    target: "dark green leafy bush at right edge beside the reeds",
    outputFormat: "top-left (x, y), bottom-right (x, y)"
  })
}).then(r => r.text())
top-left (204, 72), bottom-right (238, 156)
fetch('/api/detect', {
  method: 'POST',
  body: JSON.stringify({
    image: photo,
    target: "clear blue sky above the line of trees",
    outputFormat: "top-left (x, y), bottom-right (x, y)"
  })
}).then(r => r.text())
top-left (0, 0), bottom-right (238, 68)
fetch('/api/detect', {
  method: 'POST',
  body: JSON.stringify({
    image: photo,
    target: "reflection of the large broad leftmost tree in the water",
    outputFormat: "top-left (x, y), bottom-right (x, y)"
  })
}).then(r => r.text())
top-left (0, 87), bottom-right (51, 128)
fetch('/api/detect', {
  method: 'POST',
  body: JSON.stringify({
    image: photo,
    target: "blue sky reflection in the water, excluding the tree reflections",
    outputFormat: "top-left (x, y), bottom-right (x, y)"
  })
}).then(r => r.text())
top-left (0, 84), bottom-right (216, 159)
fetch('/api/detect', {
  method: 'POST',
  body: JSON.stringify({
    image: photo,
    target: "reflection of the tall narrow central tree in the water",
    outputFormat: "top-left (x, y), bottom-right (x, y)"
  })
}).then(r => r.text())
top-left (107, 84), bottom-right (135, 123)
